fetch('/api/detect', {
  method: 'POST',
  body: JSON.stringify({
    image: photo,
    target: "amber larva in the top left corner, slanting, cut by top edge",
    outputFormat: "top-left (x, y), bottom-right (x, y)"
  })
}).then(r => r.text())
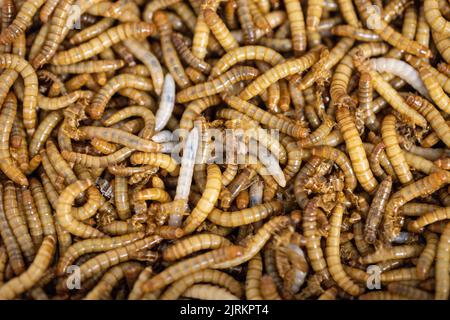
top-left (0, 0), bottom-right (45, 44)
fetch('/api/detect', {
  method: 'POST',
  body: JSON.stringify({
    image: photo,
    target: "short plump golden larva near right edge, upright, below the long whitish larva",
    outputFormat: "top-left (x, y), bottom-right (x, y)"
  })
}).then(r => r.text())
top-left (381, 114), bottom-right (413, 184)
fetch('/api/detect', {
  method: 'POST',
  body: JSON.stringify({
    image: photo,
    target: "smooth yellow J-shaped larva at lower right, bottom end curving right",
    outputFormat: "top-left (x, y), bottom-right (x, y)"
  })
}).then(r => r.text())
top-left (326, 203), bottom-right (362, 296)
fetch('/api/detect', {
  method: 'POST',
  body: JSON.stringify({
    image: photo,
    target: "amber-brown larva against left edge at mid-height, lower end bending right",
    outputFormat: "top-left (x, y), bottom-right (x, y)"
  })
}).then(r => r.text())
top-left (0, 93), bottom-right (28, 186)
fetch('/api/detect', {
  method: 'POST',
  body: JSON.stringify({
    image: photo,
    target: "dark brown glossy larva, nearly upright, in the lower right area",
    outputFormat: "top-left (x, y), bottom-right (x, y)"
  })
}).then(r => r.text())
top-left (364, 176), bottom-right (392, 244)
